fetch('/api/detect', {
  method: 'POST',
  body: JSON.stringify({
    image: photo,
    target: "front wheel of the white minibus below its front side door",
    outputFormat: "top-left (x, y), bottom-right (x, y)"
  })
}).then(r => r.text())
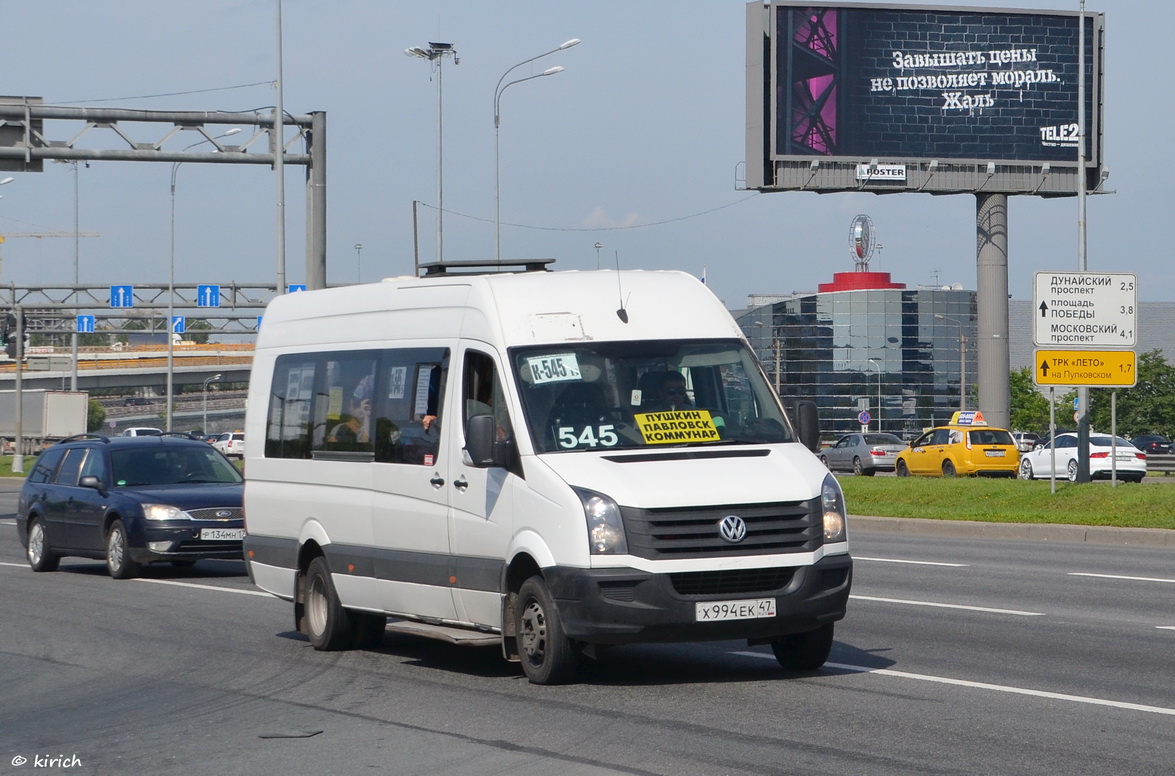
top-left (515, 576), bottom-right (579, 684)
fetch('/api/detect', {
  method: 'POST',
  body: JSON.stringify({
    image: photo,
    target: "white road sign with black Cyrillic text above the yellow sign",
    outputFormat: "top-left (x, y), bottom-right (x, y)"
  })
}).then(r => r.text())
top-left (1033, 272), bottom-right (1139, 348)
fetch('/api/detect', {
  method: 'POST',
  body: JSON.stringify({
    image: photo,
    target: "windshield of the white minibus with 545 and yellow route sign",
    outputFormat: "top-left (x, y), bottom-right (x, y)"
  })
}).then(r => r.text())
top-left (510, 340), bottom-right (795, 453)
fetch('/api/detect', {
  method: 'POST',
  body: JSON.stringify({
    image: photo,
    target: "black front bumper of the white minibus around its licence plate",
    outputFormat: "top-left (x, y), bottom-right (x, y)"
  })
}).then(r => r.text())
top-left (543, 554), bottom-right (853, 644)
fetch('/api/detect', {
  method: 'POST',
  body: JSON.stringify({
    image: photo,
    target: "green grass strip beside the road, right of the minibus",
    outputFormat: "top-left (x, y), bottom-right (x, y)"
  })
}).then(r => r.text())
top-left (839, 476), bottom-right (1175, 529)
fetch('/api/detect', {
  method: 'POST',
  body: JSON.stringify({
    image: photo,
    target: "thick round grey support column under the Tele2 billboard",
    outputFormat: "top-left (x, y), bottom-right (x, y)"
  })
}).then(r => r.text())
top-left (975, 193), bottom-right (1012, 428)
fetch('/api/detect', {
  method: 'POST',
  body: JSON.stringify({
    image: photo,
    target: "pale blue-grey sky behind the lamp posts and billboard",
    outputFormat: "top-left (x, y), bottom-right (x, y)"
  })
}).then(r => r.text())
top-left (0, 0), bottom-right (1175, 308)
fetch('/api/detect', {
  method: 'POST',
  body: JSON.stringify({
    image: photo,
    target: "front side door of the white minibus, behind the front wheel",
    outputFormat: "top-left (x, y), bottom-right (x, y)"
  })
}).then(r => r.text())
top-left (449, 348), bottom-right (515, 627)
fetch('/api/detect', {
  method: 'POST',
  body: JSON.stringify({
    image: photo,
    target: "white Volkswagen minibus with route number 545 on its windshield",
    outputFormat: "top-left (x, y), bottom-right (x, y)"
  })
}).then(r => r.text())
top-left (244, 261), bottom-right (852, 684)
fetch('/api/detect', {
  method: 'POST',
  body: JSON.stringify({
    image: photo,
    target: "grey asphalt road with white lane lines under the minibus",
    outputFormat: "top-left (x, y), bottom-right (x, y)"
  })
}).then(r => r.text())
top-left (0, 479), bottom-right (1175, 776)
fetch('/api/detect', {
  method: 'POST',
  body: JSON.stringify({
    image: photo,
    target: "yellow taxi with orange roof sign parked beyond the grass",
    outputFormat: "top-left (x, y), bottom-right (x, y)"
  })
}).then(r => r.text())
top-left (894, 412), bottom-right (1020, 477)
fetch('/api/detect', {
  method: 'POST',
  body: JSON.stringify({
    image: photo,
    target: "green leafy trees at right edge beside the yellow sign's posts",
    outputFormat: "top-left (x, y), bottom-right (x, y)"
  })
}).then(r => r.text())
top-left (1089, 349), bottom-right (1175, 439)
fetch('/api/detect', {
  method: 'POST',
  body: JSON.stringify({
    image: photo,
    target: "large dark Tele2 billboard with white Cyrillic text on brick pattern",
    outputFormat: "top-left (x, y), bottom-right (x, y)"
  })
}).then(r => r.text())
top-left (746, 1), bottom-right (1105, 195)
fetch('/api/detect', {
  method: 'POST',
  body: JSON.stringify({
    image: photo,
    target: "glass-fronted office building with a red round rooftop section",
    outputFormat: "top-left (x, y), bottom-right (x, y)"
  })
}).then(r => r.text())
top-left (738, 272), bottom-right (978, 437)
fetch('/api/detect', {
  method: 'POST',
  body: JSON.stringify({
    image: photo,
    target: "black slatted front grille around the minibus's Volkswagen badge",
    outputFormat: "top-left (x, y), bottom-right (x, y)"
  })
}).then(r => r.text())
top-left (620, 501), bottom-right (824, 560)
